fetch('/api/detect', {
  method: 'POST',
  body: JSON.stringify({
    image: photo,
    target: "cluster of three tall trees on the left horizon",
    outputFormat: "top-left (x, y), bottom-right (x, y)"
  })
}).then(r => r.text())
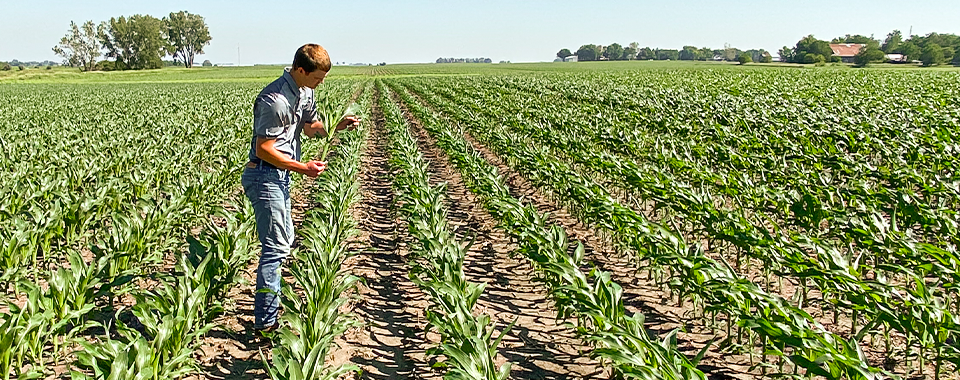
top-left (53, 11), bottom-right (212, 71)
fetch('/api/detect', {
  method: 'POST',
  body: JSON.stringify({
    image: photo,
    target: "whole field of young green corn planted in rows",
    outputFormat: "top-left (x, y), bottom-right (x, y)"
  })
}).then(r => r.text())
top-left (0, 66), bottom-right (960, 380)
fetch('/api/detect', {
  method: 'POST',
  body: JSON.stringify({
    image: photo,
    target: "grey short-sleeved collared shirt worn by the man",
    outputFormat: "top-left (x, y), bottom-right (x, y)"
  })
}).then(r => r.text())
top-left (249, 69), bottom-right (317, 165)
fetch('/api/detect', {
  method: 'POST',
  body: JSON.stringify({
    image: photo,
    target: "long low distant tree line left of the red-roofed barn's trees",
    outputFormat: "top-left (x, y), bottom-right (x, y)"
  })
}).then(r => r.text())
top-left (557, 42), bottom-right (772, 63)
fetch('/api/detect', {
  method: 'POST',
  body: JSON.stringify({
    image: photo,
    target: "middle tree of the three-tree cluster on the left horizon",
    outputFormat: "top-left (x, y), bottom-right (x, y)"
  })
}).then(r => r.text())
top-left (98, 15), bottom-right (165, 70)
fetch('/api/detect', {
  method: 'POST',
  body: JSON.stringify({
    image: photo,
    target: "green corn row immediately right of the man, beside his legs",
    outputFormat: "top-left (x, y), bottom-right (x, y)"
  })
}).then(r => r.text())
top-left (263, 81), bottom-right (371, 380)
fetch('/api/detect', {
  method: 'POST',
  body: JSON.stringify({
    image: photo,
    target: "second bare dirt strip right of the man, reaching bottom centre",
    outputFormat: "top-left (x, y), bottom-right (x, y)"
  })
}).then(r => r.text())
top-left (402, 90), bottom-right (610, 379)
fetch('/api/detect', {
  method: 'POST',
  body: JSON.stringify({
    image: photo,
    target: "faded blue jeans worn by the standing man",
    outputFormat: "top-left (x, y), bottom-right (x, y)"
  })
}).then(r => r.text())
top-left (241, 165), bottom-right (293, 329)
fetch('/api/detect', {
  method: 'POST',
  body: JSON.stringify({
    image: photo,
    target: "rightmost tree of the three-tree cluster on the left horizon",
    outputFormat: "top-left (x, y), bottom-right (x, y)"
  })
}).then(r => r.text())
top-left (163, 11), bottom-right (212, 68)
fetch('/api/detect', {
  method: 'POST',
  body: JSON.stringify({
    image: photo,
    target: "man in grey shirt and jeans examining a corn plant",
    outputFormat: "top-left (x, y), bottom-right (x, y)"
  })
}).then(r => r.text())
top-left (241, 44), bottom-right (360, 335)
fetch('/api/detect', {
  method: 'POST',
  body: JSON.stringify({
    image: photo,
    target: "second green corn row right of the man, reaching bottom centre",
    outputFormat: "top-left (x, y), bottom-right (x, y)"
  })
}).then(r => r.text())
top-left (378, 82), bottom-right (512, 380)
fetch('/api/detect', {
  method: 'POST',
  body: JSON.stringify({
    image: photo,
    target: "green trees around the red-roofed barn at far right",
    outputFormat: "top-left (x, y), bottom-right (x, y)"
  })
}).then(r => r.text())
top-left (778, 30), bottom-right (960, 66)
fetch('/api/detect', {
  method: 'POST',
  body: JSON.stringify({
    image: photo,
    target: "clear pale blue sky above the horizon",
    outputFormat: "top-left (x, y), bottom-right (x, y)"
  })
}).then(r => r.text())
top-left (0, 0), bottom-right (960, 64)
